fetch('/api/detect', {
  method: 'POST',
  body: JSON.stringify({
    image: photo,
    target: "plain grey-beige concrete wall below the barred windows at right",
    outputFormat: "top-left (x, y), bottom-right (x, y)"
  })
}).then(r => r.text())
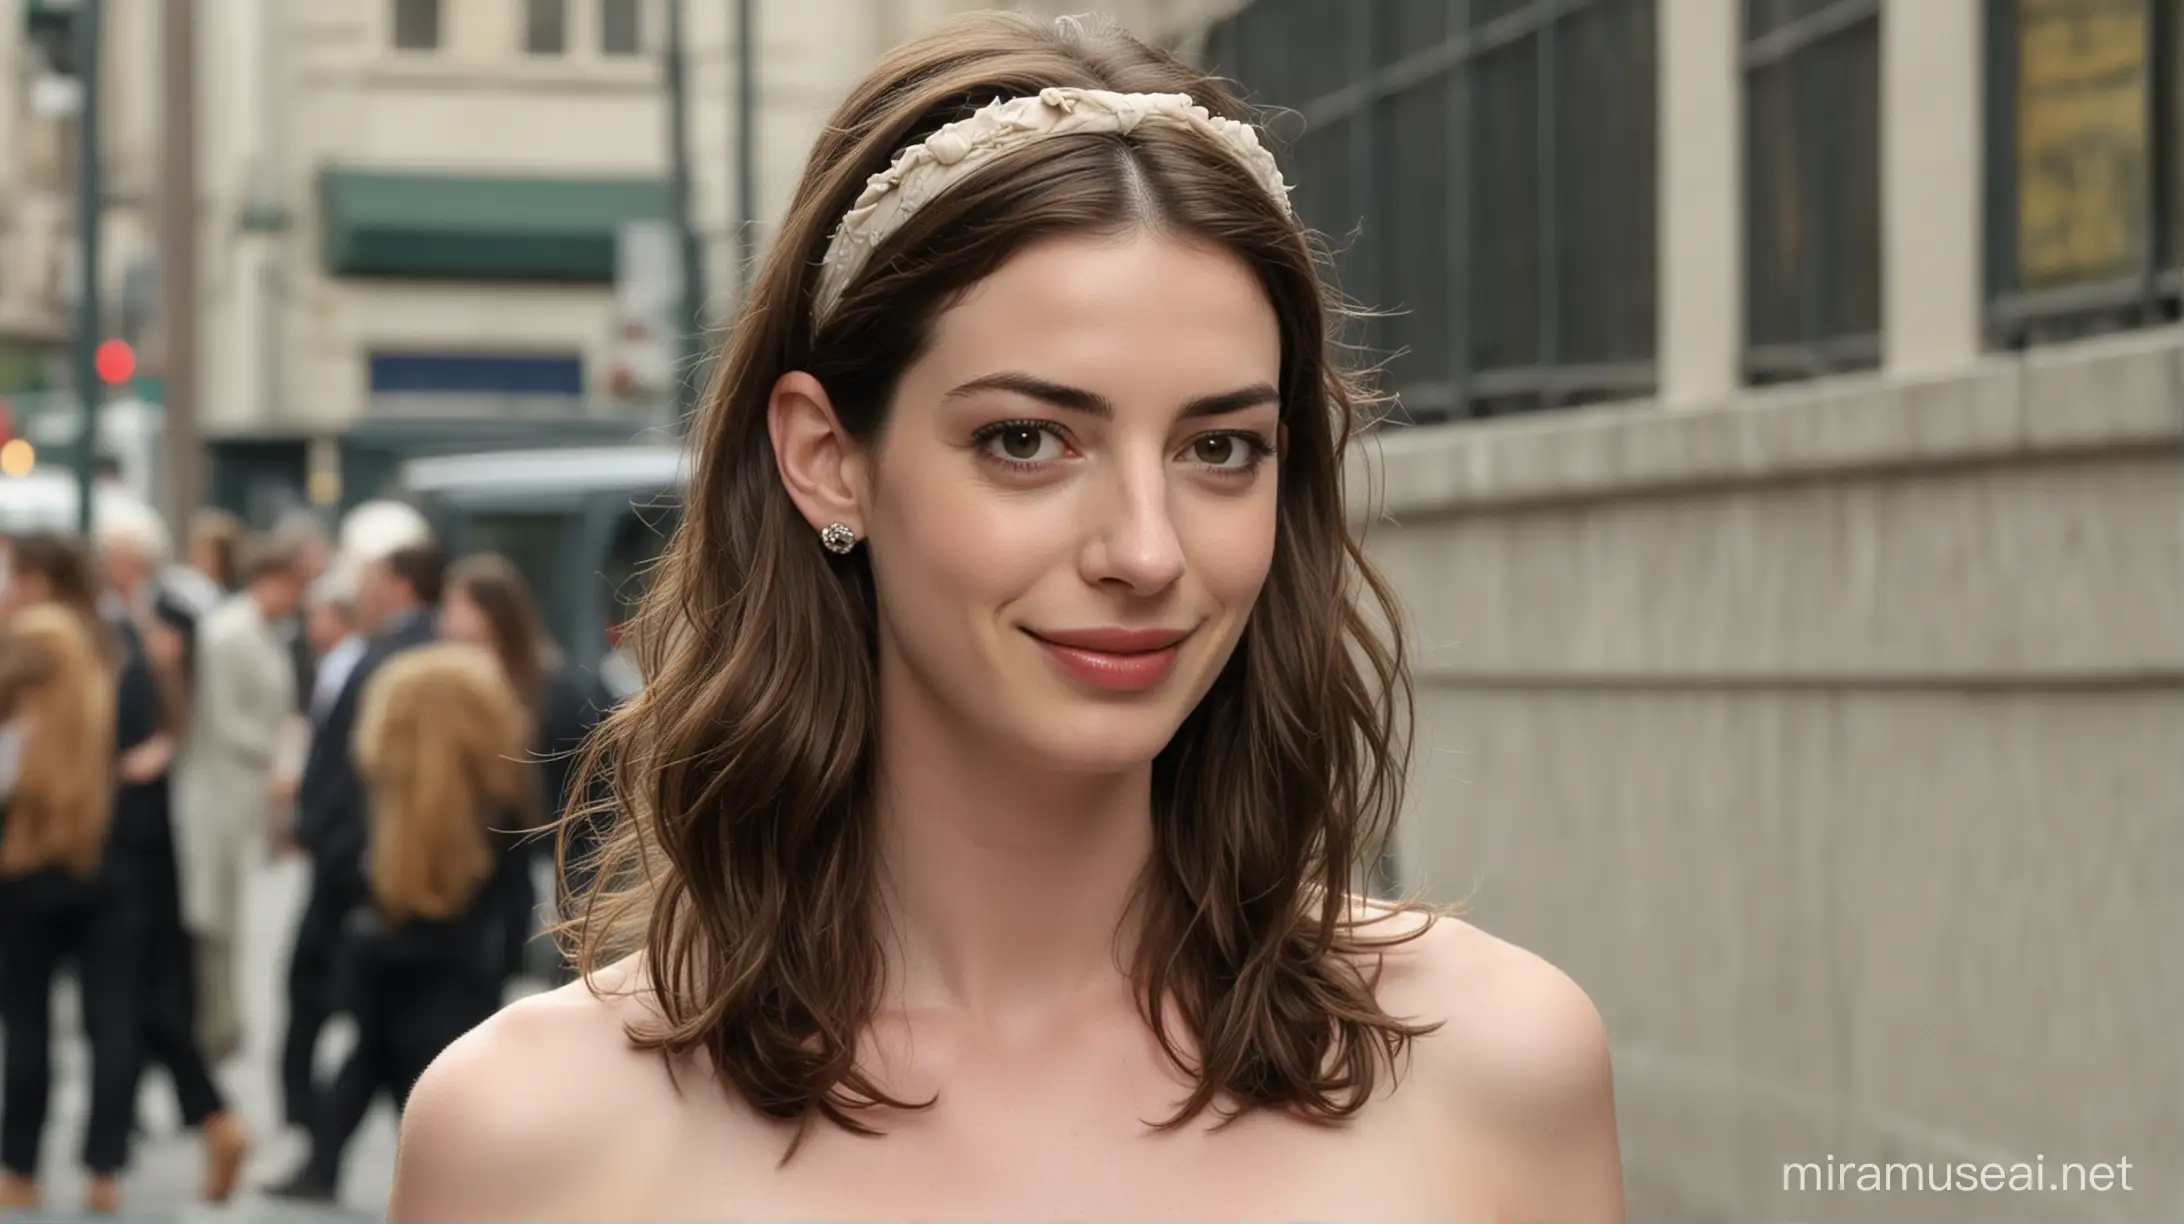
top-left (1361, 332), bottom-right (2184, 1222)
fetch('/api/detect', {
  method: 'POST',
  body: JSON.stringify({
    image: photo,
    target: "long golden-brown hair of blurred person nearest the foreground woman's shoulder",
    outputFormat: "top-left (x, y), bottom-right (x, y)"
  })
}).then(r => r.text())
top-left (356, 645), bottom-right (535, 922)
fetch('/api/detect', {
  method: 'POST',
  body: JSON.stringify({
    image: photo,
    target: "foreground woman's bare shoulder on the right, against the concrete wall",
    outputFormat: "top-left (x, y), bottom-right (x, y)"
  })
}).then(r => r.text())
top-left (1376, 914), bottom-right (1623, 1220)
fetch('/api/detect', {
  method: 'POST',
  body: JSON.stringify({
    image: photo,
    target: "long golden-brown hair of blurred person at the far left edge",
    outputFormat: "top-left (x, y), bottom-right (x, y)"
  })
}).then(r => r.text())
top-left (0, 601), bottom-right (114, 876)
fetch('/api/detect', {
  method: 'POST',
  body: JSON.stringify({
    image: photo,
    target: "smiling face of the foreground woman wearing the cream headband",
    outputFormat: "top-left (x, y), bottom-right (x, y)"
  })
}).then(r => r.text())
top-left (860, 236), bottom-right (1282, 772)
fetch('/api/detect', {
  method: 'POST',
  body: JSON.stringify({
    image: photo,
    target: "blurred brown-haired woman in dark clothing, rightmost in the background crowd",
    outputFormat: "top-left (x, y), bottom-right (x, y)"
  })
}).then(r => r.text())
top-left (439, 553), bottom-right (612, 973)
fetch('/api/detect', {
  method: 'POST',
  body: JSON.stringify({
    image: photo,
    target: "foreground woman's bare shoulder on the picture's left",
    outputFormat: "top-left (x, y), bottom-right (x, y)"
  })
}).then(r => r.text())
top-left (387, 962), bottom-right (666, 1220)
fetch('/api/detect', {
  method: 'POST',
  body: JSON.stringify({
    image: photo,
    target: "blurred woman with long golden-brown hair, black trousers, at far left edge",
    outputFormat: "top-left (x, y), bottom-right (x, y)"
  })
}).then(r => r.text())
top-left (0, 533), bottom-right (140, 1211)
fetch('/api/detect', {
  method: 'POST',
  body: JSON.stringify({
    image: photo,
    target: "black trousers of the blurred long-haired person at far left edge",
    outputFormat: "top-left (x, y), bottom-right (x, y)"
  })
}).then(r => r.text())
top-left (0, 870), bottom-right (144, 1178)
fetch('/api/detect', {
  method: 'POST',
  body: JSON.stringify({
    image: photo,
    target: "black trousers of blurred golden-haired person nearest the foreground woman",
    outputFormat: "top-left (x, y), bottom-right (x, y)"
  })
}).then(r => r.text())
top-left (304, 940), bottom-right (500, 1187)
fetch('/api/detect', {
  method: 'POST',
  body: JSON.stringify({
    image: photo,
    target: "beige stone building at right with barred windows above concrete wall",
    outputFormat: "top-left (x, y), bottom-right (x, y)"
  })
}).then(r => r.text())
top-left (1203, 0), bottom-right (2184, 1222)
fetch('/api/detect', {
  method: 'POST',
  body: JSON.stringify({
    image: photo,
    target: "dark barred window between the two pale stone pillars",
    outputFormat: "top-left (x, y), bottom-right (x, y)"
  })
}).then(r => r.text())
top-left (1743, 0), bottom-right (1880, 383)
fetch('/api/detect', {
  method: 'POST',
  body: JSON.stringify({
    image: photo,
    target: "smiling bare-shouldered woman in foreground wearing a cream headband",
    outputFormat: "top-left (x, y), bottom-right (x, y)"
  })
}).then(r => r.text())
top-left (391, 15), bottom-right (1623, 1222)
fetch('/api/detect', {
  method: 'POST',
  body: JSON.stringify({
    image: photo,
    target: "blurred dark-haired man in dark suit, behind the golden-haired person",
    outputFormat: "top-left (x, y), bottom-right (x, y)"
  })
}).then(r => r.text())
top-left (282, 538), bottom-right (446, 1128)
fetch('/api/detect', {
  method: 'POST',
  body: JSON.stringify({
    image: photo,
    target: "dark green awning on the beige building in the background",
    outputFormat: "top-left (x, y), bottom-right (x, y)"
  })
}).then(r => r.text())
top-left (319, 168), bottom-right (668, 282)
